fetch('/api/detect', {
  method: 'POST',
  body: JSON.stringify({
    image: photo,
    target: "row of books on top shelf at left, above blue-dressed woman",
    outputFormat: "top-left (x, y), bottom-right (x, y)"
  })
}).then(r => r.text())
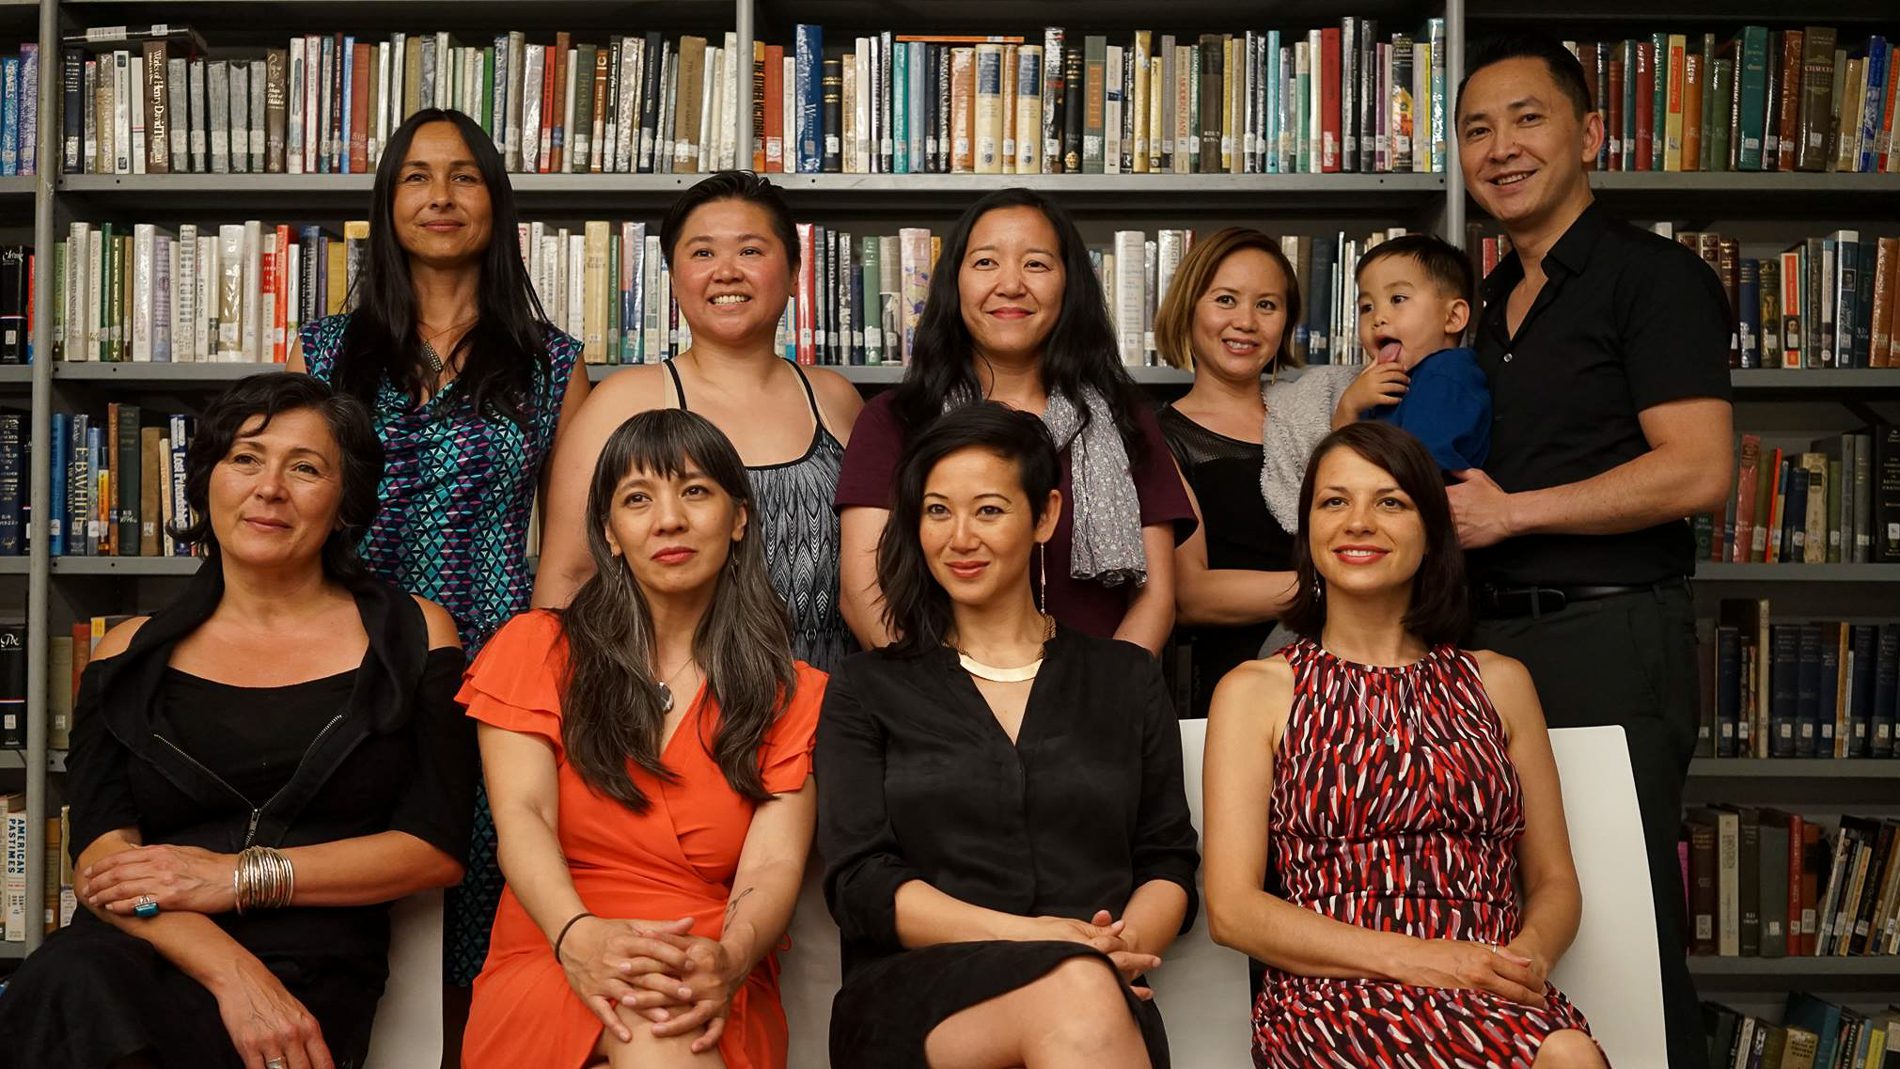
top-left (61, 27), bottom-right (751, 175)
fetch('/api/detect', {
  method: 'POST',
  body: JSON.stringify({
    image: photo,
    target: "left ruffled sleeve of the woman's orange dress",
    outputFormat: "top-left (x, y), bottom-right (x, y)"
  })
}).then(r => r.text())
top-left (456, 610), bottom-right (568, 761)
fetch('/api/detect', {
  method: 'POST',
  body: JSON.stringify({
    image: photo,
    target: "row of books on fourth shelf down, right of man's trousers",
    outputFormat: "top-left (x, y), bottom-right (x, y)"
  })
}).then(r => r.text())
top-left (1704, 598), bottom-right (1900, 758)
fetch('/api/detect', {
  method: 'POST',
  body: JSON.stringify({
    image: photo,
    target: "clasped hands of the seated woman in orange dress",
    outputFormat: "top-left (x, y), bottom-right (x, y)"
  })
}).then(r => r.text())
top-left (561, 917), bottom-right (745, 1054)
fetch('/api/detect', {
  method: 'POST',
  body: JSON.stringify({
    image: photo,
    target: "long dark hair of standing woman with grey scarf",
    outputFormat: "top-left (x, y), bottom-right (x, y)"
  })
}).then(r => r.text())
top-left (893, 186), bottom-right (1148, 459)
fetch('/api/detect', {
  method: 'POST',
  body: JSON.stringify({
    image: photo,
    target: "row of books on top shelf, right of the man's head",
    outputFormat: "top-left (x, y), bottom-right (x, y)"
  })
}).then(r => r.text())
top-left (1569, 27), bottom-right (1900, 173)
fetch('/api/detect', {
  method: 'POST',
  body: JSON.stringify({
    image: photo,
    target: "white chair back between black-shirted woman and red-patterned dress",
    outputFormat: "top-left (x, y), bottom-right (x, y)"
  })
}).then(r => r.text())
top-left (1151, 720), bottom-right (1254, 1069)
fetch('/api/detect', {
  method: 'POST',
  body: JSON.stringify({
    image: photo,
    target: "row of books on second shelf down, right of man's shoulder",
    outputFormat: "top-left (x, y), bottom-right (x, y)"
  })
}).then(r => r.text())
top-left (1659, 226), bottom-right (1900, 368)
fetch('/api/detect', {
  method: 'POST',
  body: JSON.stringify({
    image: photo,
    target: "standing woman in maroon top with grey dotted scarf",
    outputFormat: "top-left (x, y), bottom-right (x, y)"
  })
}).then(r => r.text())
top-left (836, 188), bottom-right (1195, 651)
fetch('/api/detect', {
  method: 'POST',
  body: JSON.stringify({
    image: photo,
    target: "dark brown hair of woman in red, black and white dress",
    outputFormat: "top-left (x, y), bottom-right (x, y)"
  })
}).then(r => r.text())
top-left (1281, 422), bottom-right (1471, 646)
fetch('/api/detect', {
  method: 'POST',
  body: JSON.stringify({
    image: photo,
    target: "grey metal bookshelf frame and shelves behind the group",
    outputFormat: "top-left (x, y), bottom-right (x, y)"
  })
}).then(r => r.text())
top-left (0, 0), bottom-right (1900, 1048)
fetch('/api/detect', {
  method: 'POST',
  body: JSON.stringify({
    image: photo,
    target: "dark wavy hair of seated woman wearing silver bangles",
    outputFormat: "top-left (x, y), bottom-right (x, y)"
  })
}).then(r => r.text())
top-left (167, 372), bottom-right (382, 581)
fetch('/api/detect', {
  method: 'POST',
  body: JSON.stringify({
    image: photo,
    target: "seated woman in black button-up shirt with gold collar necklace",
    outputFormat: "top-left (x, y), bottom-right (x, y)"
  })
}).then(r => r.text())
top-left (817, 403), bottom-right (1199, 1069)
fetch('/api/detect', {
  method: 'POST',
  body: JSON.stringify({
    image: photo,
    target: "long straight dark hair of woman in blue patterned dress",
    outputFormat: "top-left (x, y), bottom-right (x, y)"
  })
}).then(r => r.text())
top-left (331, 108), bottom-right (551, 425)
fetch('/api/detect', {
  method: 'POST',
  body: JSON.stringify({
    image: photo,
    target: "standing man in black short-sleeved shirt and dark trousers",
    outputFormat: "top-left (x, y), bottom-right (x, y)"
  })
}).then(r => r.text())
top-left (1450, 34), bottom-right (1733, 1069)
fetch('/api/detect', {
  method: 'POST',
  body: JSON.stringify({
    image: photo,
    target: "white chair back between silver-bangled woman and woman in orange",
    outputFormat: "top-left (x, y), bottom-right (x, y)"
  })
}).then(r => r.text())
top-left (365, 891), bottom-right (443, 1069)
